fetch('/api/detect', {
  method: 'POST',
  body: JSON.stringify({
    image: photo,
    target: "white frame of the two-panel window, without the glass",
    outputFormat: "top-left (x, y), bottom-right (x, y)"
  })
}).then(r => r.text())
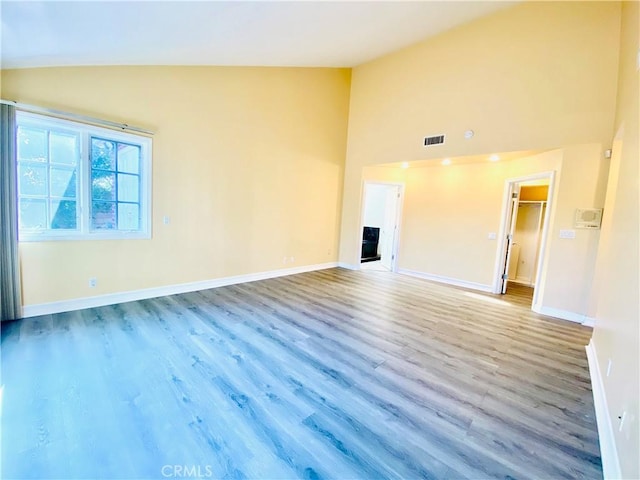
top-left (16, 111), bottom-right (153, 242)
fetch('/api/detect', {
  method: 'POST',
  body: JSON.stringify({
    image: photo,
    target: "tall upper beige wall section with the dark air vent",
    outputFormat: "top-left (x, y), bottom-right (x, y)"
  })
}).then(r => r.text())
top-left (340, 2), bottom-right (620, 268)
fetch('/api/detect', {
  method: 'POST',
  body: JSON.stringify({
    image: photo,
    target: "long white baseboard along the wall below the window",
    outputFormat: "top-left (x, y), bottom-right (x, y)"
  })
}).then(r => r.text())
top-left (22, 262), bottom-right (338, 318)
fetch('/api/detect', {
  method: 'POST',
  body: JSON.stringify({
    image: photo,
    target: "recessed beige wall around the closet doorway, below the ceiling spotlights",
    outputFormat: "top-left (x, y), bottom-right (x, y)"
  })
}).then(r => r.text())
top-left (398, 144), bottom-right (608, 316)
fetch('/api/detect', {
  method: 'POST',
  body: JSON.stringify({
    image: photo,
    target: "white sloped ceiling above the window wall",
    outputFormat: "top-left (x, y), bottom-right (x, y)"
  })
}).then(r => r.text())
top-left (0, 0), bottom-right (517, 68)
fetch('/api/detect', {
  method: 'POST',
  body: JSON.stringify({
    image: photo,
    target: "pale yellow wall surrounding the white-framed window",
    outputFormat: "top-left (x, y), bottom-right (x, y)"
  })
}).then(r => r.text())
top-left (2, 67), bottom-right (350, 305)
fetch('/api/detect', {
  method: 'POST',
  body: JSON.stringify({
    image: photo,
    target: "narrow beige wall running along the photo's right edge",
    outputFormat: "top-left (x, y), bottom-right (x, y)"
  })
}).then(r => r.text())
top-left (592, 2), bottom-right (640, 479)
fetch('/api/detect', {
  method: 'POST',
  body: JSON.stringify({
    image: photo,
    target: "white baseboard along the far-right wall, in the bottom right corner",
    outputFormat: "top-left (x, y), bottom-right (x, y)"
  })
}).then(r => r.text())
top-left (585, 339), bottom-right (622, 480)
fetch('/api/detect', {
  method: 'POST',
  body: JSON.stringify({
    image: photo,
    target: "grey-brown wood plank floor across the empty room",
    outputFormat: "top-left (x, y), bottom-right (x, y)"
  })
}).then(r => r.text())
top-left (2, 269), bottom-right (602, 479)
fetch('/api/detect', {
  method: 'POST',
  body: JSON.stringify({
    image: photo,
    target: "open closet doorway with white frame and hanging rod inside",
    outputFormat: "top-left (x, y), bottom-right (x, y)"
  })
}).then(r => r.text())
top-left (494, 172), bottom-right (555, 305)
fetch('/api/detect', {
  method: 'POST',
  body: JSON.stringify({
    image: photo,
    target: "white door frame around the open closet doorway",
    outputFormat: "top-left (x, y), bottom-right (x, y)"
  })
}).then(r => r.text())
top-left (492, 170), bottom-right (556, 306)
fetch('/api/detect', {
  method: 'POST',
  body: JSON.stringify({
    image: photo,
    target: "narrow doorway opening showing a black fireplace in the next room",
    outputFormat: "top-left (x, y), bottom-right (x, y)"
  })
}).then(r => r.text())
top-left (360, 182), bottom-right (403, 272)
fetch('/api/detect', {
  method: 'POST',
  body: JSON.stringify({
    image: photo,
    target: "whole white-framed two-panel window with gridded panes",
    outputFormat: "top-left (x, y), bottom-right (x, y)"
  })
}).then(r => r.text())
top-left (17, 112), bottom-right (151, 241)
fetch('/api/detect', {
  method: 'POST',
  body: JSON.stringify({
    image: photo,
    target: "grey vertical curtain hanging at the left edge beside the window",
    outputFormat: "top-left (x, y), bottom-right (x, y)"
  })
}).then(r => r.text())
top-left (0, 104), bottom-right (22, 321)
